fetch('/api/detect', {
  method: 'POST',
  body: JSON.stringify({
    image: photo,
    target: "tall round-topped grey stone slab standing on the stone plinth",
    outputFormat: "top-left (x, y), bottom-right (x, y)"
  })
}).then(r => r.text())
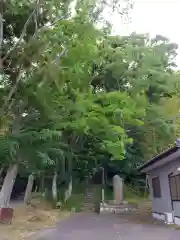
top-left (113, 175), bottom-right (123, 204)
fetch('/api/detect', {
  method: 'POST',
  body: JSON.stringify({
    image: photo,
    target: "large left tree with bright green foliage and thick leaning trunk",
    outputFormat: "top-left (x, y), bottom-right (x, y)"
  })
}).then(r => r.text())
top-left (0, 1), bottom-right (136, 206)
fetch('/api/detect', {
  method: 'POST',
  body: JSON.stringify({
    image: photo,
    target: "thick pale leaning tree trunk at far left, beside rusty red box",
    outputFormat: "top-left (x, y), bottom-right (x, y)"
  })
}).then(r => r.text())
top-left (0, 164), bottom-right (18, 208)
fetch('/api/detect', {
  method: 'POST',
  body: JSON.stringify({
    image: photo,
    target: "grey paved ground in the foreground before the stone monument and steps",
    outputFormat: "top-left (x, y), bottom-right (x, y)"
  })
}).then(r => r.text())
top-left (30, 214), bottom-right (180, 240)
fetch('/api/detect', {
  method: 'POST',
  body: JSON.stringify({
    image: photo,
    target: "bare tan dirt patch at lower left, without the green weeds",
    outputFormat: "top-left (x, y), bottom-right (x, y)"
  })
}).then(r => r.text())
top-left (0, 200), bottom-right (70, 240)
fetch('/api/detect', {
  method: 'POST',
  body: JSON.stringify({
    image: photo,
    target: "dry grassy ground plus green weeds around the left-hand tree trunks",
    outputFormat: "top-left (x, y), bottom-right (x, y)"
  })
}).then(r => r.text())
top-left (0, 186), bottom-right (86, 240)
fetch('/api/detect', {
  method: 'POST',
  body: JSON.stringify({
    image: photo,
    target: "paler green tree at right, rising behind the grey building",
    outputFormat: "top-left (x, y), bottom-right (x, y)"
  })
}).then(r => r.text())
top-left (92, 33), bottom-right (179, 172)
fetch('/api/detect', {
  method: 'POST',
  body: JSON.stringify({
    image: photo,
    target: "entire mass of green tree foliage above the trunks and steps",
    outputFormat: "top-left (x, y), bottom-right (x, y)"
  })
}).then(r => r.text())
top-left (0, 0), bottom-right (179, 199)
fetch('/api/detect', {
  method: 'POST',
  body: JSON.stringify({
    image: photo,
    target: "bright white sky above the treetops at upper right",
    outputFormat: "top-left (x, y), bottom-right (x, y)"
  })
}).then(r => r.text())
top-left (111, 0), bottom-right (180, 67)
